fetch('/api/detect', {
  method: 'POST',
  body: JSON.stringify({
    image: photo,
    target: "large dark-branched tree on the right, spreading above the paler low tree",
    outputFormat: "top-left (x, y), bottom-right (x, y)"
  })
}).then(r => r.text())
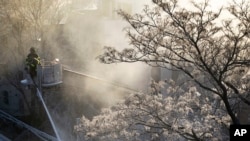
top-left (97, 0), bottom-right (250, 124)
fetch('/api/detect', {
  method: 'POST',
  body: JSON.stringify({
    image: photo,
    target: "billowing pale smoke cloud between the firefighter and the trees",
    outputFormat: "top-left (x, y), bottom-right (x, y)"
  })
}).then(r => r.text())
top-left (32, 1), bottom-right (153, 140)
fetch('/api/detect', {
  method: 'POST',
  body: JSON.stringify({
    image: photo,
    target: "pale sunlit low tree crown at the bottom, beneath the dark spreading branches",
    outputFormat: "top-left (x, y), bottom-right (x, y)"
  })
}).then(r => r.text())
top-left (75, 81), bottom-right (230, 141)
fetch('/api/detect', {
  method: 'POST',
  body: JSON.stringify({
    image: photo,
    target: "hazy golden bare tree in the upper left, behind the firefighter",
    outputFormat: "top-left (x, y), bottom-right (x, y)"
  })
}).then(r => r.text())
top-left (0, 0), bottom-right (68, 115)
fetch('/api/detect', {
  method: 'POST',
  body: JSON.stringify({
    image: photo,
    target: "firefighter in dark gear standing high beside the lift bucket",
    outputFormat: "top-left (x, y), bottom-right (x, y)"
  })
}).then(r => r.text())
top-left (26, 47), bottom-right (40, 78)
